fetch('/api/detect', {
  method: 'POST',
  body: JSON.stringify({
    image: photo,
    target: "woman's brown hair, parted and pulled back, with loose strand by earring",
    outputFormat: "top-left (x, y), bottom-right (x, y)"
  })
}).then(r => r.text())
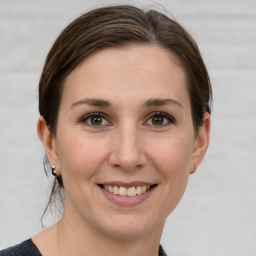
top-left (39, 5), bottom-right (211, 221)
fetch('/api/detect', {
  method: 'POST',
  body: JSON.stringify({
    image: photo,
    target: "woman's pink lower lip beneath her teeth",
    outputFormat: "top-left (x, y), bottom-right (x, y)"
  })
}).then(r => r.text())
top-left (100, 186), bottom-right (156, 206)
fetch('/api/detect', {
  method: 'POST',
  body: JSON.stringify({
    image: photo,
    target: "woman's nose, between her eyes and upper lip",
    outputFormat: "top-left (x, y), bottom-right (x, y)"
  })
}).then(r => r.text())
top-left (109, 127), bottom-right (147, 172)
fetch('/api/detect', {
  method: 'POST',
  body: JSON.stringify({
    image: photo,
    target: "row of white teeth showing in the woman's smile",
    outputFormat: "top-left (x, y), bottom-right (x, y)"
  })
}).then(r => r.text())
top-left (103, 185), bottom-right (150, 196)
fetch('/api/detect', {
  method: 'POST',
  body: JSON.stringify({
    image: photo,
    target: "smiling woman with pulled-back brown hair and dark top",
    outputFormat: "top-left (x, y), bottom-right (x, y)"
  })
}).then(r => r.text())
top-left (1, 6), bottom-right (211, 256)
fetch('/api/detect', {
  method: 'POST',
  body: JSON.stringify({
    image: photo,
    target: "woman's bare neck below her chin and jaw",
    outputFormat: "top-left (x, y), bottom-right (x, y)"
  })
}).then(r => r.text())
top-left (56, 207), bottom-right (164, 256)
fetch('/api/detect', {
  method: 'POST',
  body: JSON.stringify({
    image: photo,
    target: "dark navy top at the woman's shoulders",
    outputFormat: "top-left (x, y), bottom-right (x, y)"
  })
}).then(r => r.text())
top-left (0, 239), bottom-right (167, 256)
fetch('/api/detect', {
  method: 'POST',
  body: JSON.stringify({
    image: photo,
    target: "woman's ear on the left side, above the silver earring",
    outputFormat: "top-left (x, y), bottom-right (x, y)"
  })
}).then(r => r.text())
top-left (37, 116), bottom-right (59, 175)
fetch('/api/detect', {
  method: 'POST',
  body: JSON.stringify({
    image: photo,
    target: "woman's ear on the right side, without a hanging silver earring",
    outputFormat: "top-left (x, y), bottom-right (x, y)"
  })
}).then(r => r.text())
top-left (190, 112), bottom-right (211, 174)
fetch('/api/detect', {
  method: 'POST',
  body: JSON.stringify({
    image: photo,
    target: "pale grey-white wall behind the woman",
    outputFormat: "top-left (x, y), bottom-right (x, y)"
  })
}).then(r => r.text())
top-left (0, 0), bottom-right (256, 256)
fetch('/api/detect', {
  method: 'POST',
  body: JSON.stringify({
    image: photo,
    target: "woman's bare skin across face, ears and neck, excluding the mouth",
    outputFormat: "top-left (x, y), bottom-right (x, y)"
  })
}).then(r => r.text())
top-left (33, 46), bottom-right (210, 256)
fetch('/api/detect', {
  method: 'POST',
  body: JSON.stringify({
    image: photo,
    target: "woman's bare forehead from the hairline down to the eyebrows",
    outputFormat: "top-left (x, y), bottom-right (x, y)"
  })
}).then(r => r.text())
top-left (62, 46), bottom-right (188, 107)
